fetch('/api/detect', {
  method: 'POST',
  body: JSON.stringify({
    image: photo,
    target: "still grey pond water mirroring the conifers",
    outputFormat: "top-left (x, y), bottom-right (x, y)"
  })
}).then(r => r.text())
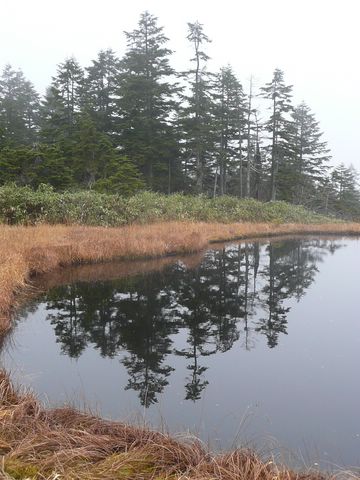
top-left (1, 238), bottom-right (360, 468)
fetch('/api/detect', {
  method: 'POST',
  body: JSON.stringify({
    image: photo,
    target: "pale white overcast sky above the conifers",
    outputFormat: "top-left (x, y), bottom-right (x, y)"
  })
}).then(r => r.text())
top-left (0, 0), bottom-right (360, 170)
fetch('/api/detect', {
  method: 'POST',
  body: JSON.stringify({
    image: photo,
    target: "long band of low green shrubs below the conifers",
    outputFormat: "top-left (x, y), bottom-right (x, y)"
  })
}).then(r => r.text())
top-left (0, 184), bottom-right (329, 226)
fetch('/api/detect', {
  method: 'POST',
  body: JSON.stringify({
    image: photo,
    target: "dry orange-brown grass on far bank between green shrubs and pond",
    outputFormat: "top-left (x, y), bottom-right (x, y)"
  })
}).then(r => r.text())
top-left (0, 222), bottom-right (360, 333)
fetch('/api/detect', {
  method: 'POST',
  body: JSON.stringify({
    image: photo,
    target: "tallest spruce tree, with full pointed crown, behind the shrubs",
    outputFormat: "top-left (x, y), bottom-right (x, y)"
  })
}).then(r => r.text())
top-left (119, 12), bottom-right (177, 190)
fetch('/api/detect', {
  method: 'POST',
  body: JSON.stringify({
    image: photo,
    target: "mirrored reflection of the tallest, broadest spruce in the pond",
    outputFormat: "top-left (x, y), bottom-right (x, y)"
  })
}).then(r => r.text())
top-left (117, 274), bottom-right (177, 407)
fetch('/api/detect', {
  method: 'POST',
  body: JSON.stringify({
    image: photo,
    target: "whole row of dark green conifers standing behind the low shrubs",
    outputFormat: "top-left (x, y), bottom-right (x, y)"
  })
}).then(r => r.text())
top-left (0, 12), bottom-right (360, 216)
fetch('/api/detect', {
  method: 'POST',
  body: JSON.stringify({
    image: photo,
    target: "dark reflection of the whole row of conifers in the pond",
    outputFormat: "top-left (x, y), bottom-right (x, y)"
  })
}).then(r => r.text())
top-left (19, 239), bottom-right (341, 407)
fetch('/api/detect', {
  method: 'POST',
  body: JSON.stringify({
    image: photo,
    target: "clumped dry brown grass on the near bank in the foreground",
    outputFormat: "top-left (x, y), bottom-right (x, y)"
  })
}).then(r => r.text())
top-left (0, 372), bottom-right (358, 480)
